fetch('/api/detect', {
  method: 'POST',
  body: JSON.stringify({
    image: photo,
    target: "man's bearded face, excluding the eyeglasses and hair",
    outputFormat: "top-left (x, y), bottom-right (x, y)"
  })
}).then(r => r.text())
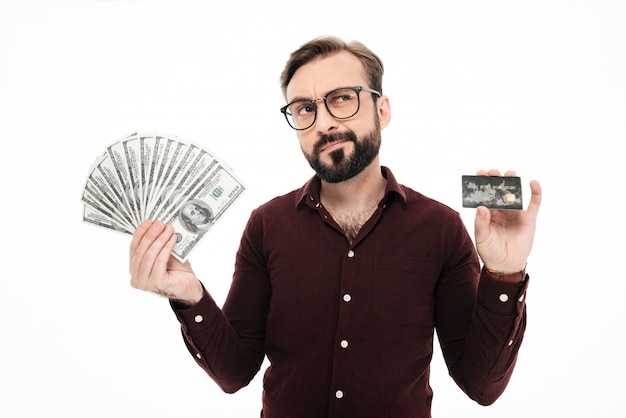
top-left (286, 52), bottom-right (387, 183)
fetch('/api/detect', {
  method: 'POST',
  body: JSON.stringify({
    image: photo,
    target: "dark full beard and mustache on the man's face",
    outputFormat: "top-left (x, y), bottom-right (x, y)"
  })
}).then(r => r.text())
top-left (304, 121), bottom-right (381, 183)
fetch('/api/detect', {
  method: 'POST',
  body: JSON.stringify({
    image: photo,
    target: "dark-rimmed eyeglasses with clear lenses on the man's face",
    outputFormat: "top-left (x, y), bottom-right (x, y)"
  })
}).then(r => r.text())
top-left (280, 86), bottom-right (380, 131)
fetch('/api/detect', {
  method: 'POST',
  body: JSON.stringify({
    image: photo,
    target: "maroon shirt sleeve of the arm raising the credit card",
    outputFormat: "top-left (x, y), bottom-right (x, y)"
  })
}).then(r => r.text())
top-left (436, 212), bottom-right (529, 405)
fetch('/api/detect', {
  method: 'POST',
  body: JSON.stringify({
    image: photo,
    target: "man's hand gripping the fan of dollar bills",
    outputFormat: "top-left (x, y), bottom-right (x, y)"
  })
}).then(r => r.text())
top-left (130, 220), bottom-right (203, 306)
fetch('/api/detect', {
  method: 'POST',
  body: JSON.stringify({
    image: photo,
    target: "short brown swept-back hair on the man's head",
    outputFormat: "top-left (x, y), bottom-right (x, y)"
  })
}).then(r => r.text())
top-left (280, 36), bottom-right (384, 97)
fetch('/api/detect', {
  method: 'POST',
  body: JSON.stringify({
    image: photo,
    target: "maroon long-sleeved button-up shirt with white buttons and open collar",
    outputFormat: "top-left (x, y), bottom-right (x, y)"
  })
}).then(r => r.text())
top-left (172, 167), bottom-right (528, 418)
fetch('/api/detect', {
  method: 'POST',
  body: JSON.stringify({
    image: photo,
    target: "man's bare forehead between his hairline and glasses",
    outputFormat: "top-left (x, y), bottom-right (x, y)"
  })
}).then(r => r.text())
top-left (286, 51), bottom-right (369, 101)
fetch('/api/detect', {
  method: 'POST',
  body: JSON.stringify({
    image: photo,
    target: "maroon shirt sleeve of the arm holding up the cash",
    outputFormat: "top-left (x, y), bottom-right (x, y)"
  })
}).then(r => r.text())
top-left (170, 209), bottom-right (270, 393)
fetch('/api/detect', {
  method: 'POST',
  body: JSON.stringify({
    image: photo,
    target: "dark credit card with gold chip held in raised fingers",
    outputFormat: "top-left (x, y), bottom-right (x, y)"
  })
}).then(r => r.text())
top-left (461, 176), bottom-right (523, 210)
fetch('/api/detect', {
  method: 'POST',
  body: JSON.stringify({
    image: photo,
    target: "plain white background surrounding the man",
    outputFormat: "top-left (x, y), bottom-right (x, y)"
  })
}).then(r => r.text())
top-left (0, 0), bottom-right (626, 418)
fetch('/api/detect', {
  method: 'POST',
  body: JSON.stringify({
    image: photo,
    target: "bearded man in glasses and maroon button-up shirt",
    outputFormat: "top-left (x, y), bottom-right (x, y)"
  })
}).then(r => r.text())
top-left (130, 38), bottom-right (541, 418)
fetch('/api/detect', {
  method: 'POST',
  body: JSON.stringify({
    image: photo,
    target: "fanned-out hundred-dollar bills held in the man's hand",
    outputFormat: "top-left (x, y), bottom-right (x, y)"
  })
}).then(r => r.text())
top-left (82, 132), bottom-right (245, 262)
